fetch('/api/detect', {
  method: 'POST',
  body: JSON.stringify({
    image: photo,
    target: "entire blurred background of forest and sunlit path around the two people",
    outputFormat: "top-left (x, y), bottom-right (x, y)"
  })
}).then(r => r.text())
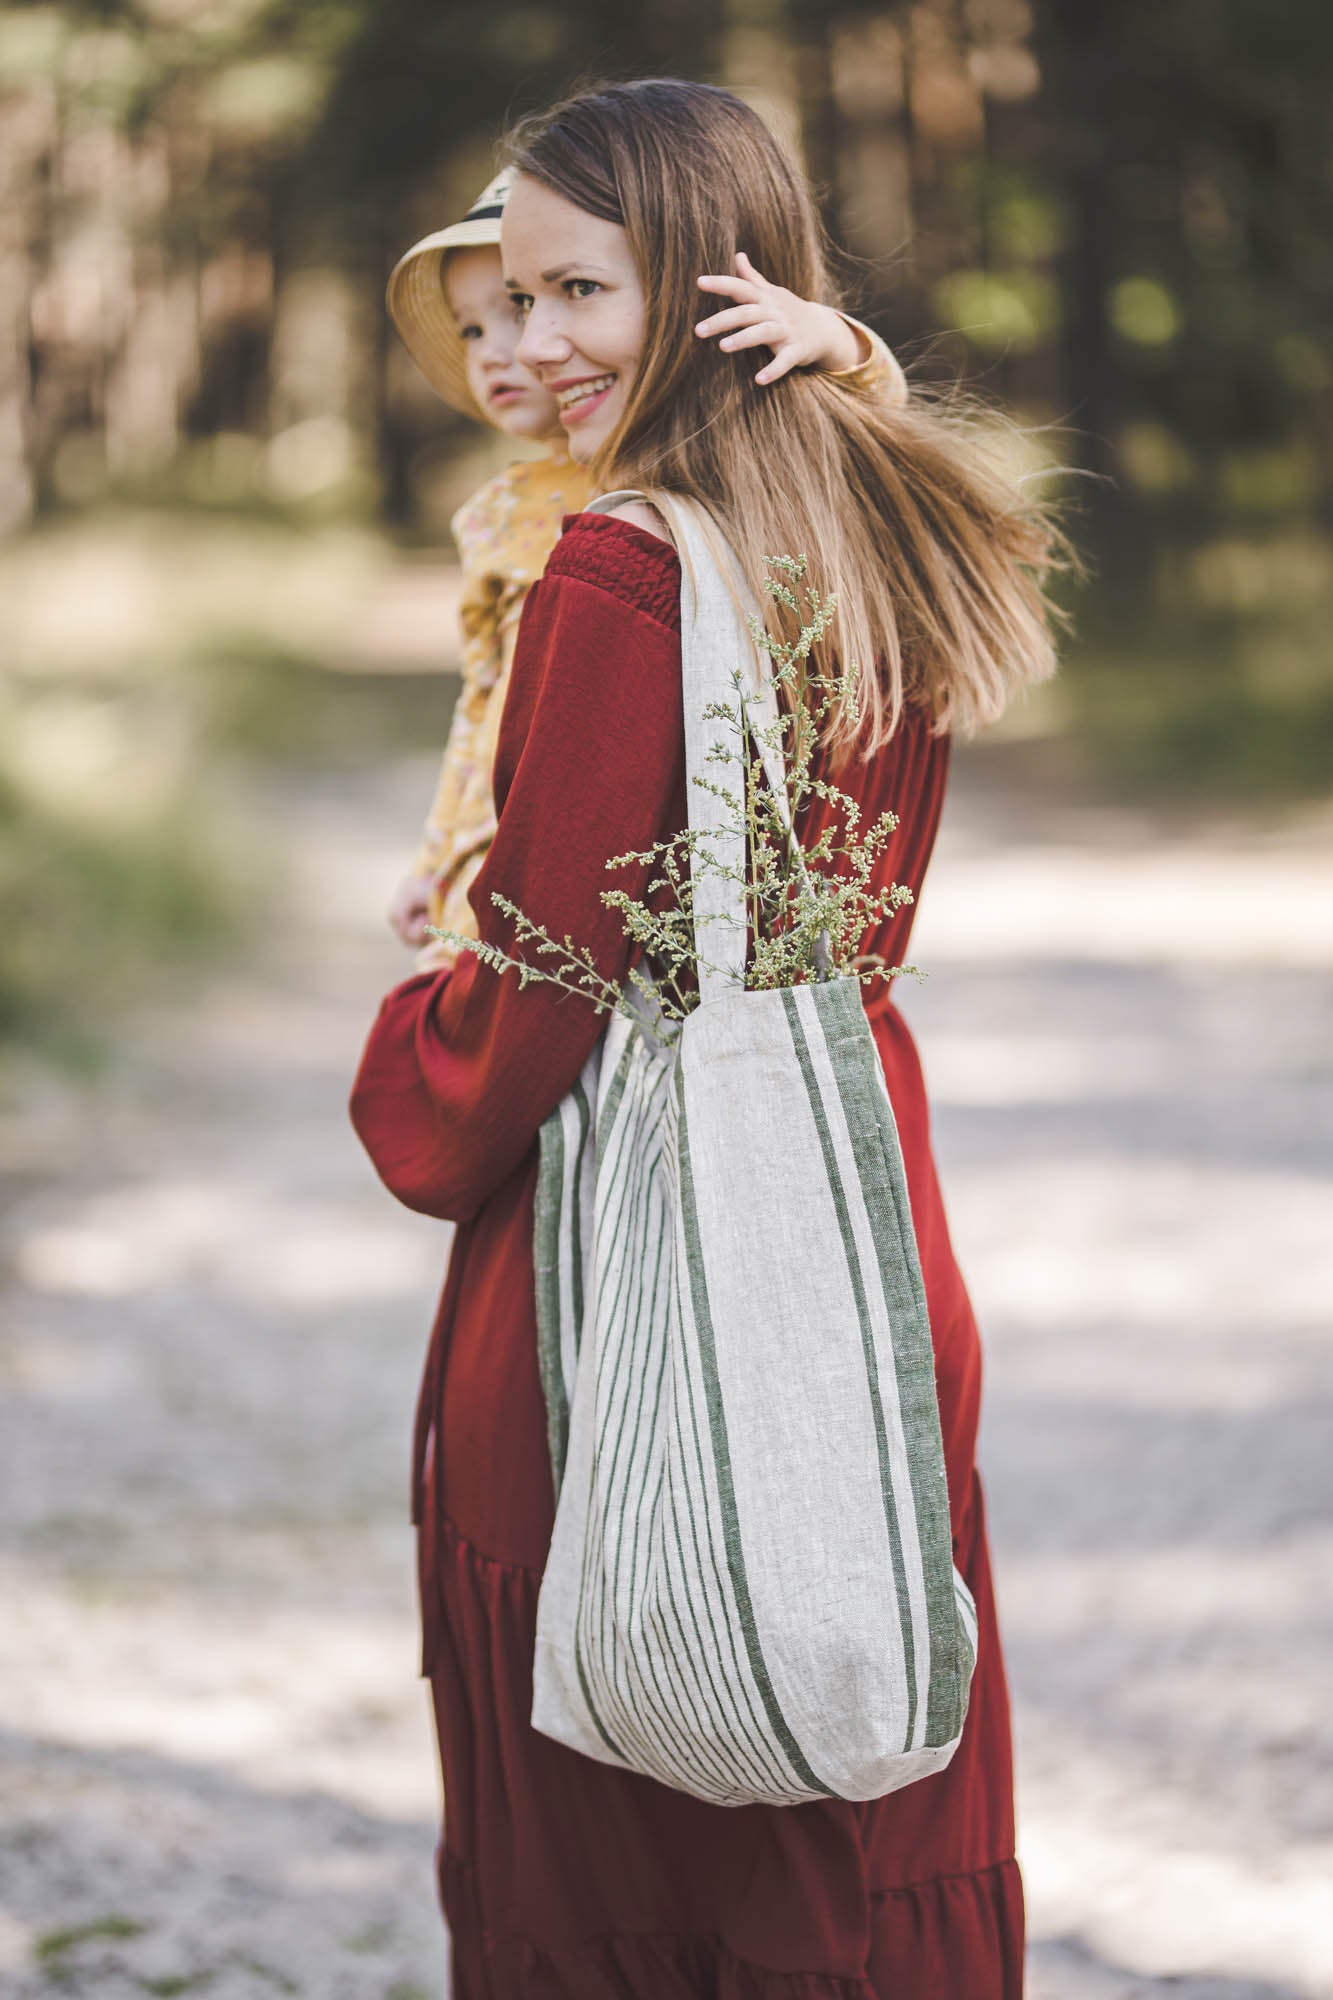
top-left (0, 0), bottom-right (1333, 2000)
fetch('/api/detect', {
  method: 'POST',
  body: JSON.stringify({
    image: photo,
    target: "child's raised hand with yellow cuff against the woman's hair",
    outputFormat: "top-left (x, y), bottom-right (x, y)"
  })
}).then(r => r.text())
top-left (695, 250), bottom-right (907, 406)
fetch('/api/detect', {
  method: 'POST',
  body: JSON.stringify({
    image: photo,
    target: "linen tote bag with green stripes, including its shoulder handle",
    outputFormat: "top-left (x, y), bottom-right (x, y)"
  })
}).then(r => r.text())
top-left (532, 494), bottom-right (977, 1806)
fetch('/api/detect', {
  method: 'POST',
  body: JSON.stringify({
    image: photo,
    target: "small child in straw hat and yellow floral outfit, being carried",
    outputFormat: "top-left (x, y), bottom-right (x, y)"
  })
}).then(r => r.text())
top-left (388, 174), bottom-right (907, 970)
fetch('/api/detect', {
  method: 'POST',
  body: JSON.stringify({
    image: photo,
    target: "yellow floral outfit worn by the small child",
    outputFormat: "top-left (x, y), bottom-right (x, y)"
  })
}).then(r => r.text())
top-left (412, 320), bottom-right (907, 972)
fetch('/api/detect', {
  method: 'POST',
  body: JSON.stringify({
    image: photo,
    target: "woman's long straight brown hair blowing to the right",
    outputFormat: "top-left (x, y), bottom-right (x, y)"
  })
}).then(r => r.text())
top-left (506, 78), bottom-right (1061, 754)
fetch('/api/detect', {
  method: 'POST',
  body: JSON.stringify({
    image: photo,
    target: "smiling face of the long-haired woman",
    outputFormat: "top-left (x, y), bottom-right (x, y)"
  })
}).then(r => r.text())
top-left (500, 174), bottom-right (646, 464)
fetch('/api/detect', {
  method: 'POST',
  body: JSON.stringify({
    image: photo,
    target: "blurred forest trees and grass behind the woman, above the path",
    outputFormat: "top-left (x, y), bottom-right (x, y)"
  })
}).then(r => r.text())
top-left (0, 0), bottom-right (1333, 1054)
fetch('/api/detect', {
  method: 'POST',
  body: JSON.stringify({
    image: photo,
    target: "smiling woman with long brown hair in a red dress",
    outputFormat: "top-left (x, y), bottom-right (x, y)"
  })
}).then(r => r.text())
top-left (352, 70), bottom-right (1051, 2000)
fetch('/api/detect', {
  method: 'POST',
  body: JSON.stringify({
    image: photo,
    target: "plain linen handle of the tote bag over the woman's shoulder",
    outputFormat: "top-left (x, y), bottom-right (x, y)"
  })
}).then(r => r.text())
top-left (584, 488), bottom-right (827, 1004)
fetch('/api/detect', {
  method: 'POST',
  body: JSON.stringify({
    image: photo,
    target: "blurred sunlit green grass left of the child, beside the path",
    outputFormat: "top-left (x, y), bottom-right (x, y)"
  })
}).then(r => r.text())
top-left (0, 514), bottom-right (452, 1070)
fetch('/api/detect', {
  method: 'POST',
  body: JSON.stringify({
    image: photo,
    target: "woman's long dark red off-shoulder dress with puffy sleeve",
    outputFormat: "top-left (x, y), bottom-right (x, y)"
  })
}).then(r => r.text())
top-left (352, 514), bottom-right (1023, 2000)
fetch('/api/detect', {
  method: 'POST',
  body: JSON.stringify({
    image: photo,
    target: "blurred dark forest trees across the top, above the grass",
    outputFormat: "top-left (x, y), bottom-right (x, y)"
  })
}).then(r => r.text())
top-left (0, 0), bottom-right (1333, 544)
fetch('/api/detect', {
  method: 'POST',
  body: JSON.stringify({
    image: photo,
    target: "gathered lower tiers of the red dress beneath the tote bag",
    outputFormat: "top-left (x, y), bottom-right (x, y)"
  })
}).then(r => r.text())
top-left (422, 1504), bottom-right (1023, 2000)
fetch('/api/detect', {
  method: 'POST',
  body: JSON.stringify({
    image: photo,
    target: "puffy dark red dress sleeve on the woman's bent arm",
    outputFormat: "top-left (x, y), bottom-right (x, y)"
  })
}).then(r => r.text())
top-left (352, 514), bottom-right (685, 1222)
